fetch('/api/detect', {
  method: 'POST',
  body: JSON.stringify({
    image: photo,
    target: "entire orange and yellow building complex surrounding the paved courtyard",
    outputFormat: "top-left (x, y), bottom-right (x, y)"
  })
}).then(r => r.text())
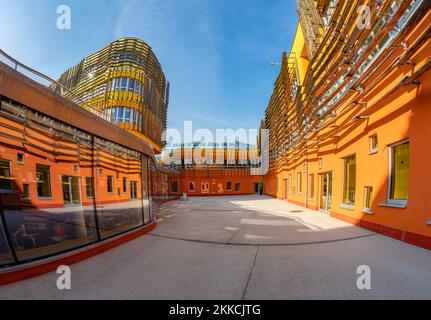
top-left (0, 0), bottom-right (431, 284)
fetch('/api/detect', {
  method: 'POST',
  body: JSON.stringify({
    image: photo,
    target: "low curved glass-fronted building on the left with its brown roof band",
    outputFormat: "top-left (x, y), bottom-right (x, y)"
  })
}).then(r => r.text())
top-left (0, 47), bottom-right (179, 276)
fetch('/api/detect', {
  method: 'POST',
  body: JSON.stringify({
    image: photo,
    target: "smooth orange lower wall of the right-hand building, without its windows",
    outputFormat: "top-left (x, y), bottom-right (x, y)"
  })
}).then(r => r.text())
top-left (265, 13), bottom-right (431, 242)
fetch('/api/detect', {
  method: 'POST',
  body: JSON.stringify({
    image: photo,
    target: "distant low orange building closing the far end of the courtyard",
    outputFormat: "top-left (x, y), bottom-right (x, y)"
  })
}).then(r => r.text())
top-left (162, 143), bottom-right (263, 196)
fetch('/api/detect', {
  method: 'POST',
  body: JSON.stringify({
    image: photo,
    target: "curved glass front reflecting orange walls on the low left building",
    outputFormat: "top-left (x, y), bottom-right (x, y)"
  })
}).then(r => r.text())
top-left (0, 99), bottom-right (178, 267)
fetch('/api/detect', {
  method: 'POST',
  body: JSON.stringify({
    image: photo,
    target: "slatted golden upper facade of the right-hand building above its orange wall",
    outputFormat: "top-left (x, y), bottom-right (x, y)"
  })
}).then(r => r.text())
top-left (264, 0), bottom-right (431, 170)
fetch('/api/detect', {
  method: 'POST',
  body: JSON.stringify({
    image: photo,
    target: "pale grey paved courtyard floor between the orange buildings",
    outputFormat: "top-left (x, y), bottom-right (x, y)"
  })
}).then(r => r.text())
top-left (0, 196), bottom-right (431, 299)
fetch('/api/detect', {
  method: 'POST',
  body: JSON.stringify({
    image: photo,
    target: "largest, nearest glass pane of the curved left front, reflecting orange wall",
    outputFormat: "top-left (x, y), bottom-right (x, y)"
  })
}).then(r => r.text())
top-left (0, 105), bottom-right (97, 261)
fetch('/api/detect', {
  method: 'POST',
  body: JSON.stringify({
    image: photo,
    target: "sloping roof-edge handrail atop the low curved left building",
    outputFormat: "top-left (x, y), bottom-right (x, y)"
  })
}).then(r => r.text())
top-left (0, 49), bottom-right (108, 121)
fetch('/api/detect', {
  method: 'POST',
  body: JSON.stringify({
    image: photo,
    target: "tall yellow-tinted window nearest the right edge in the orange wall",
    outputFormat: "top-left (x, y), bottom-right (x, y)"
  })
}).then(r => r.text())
top-left (389, 141), bottom-right (410, 202)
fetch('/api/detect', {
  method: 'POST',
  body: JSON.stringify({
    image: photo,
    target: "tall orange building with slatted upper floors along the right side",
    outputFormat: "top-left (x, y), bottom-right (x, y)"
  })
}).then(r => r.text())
top-left (263, 0), bottom-right (431, 248)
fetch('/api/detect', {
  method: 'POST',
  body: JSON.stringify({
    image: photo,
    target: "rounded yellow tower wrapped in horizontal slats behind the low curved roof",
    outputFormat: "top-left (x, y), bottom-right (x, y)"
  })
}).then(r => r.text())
top-left (54, 38), bottom-right (169, 153)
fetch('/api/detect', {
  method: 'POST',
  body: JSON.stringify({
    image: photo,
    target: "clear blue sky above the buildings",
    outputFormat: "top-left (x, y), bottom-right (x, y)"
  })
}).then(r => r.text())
top-left (0, 0), bottom-right (297, 137)
